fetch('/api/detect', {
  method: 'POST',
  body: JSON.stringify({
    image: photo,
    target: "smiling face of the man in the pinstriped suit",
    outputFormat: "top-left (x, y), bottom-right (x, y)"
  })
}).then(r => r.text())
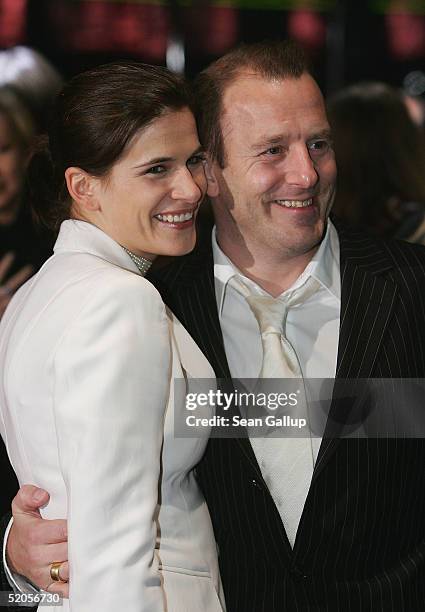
top-left (214, 74), bottom-right (336, 257)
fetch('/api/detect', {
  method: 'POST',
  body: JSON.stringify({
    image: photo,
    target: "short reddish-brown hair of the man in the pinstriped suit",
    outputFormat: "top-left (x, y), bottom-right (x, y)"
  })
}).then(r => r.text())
top-left (195, 40), bottom-right (309, 167)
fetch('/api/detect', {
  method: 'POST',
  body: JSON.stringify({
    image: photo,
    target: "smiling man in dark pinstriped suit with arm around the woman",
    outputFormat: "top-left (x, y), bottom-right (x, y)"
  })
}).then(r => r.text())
top-left (2, 43), bottom-right (425, 612)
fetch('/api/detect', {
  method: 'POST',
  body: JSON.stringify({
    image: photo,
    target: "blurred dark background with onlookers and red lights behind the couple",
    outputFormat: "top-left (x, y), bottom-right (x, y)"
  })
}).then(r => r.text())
top-left (0, 0), bottom-right (425, 514)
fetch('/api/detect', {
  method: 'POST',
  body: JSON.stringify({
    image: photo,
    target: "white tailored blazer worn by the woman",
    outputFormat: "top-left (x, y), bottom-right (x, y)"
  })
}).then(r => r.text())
top-left (0, 220), bottom-right (224, 612)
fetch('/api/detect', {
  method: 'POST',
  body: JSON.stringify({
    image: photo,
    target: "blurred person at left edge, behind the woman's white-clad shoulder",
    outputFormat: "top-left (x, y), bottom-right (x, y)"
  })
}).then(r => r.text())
top-left (0, 87), bottom-right (51, 317)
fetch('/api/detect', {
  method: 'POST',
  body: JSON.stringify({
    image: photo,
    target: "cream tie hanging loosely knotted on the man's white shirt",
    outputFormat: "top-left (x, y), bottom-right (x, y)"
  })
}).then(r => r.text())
top-left (229, 276), bottom-right (320, 546)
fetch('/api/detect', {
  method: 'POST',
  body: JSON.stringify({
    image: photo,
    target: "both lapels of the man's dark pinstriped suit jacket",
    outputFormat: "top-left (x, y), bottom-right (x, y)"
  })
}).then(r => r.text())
top-left (156, 224), bottom-right (397, 558)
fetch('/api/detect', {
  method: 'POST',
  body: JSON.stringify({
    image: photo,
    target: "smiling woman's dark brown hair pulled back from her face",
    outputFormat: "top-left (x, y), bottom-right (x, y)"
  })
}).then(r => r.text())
top-left (27, 62), bottom-right (194, 231)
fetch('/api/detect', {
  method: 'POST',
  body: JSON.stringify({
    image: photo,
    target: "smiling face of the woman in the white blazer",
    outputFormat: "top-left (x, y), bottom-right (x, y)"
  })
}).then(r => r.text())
top-left (93, 109), bottom-right (207, 257)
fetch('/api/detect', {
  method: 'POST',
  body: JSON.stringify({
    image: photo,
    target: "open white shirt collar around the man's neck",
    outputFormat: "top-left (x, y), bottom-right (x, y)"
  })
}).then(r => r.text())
top-left (212, 219), bottom-right (341, 316)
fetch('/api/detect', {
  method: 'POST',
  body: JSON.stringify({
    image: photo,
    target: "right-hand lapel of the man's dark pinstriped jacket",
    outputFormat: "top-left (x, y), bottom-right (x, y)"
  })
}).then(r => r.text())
top-left (312, 229), bottom-right (397, 482)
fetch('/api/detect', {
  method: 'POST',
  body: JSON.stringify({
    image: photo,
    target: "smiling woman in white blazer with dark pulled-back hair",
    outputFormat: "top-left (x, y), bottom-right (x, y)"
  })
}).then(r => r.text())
top-left (0, 63), bottom-right (224, 612)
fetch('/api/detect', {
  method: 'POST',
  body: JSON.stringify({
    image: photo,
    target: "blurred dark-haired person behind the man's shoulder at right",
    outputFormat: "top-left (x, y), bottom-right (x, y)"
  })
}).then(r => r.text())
top-left (328, 82), bottom-right (425, 244)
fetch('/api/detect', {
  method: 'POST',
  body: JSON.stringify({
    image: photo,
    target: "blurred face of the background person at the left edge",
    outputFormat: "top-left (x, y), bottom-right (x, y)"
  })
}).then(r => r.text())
top-left (0, 113), bottom-right (24, 217)
